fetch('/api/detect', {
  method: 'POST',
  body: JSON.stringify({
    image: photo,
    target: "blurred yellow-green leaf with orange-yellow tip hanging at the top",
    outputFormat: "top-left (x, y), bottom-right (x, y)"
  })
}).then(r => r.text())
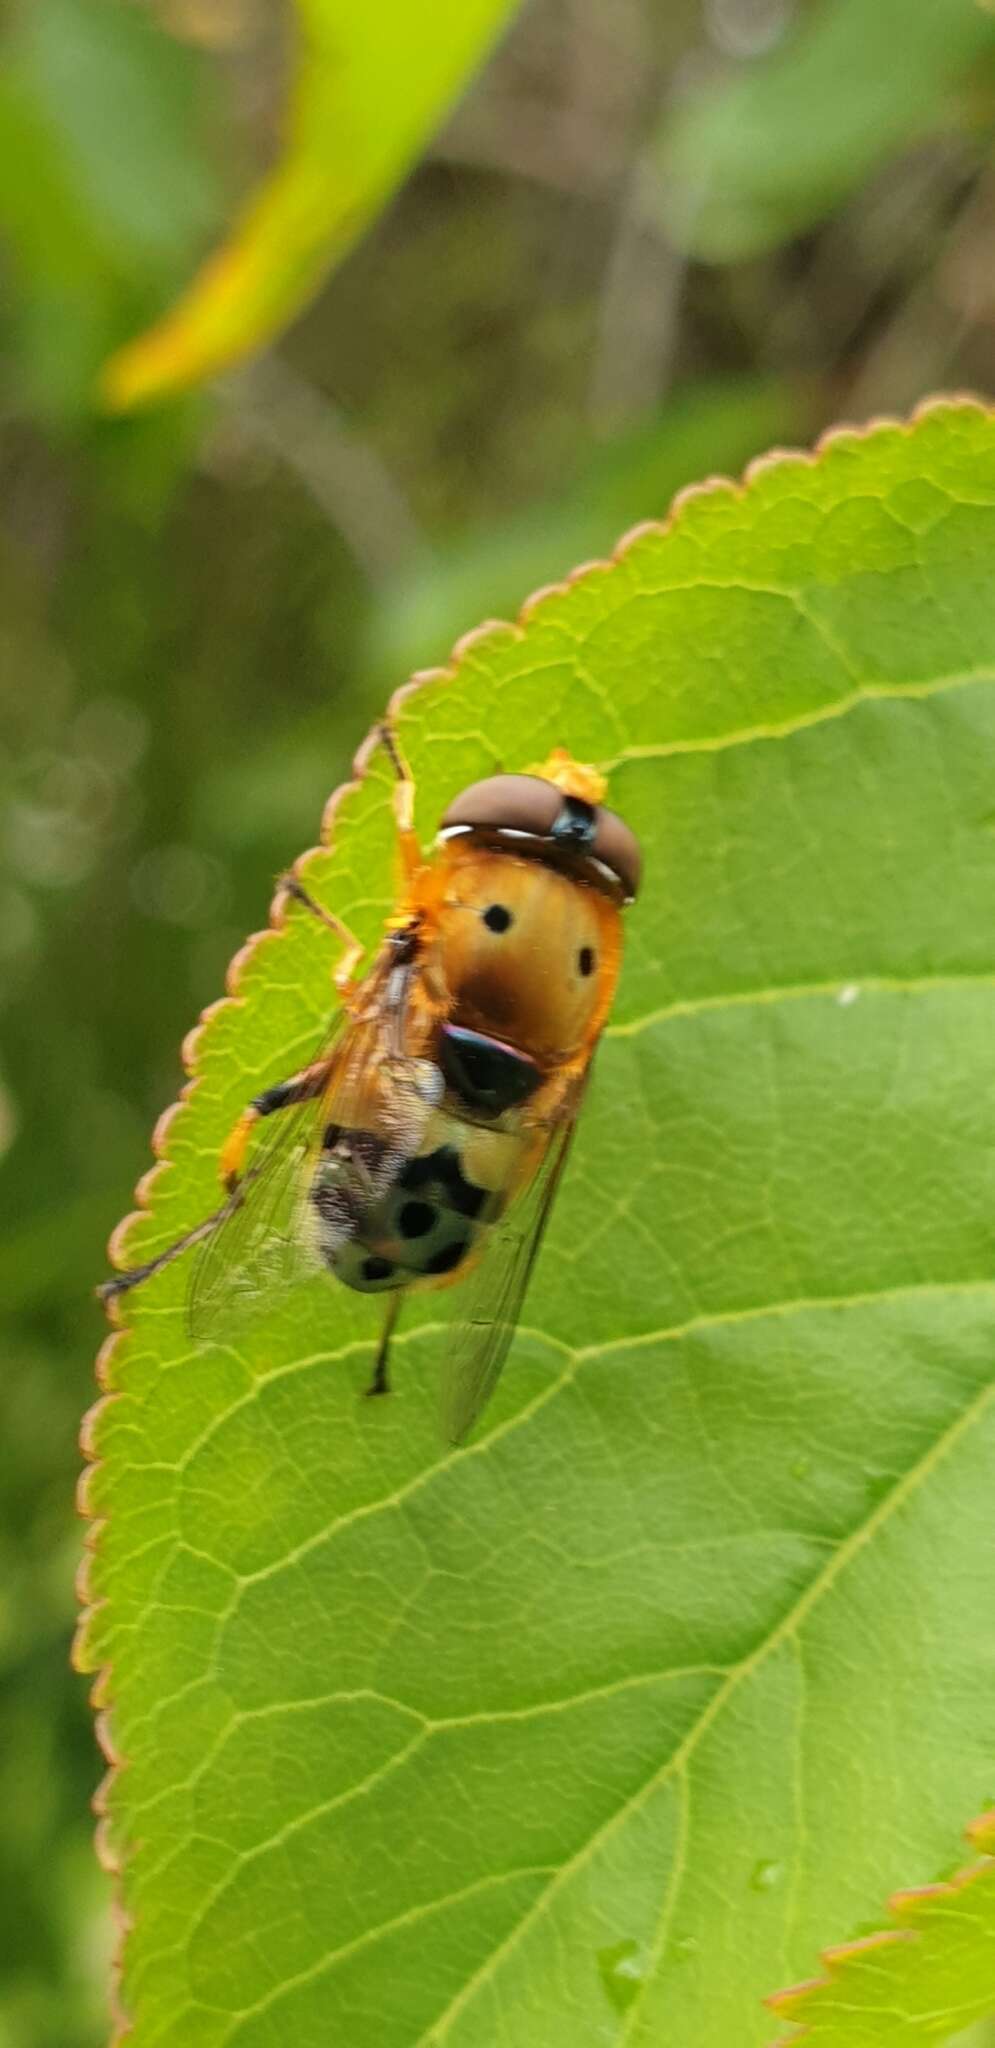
top-left (102, 0), bottom-right (514, 410)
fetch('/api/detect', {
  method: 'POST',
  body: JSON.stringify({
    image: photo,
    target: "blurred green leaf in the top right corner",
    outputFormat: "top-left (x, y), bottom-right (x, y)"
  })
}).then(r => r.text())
top-left (659, 0), bottom-right (995, 262)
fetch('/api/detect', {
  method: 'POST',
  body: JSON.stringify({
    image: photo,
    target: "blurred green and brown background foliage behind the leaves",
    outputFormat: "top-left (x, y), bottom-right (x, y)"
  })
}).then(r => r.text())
top-left (0, 0), bottom-right (995, 2048)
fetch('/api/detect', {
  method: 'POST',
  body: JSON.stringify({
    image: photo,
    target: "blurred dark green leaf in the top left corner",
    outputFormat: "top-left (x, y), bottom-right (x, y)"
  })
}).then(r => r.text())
top-left (0, 0), bottom-right (219, 418)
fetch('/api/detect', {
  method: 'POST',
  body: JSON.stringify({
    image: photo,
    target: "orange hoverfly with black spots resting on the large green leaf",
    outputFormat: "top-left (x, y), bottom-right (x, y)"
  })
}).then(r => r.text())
top-left (100, 725), bottom-right (641, 1442)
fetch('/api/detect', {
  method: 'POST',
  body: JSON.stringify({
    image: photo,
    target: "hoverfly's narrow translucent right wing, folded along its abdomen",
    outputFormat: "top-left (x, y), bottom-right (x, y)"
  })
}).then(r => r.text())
top-left (442, 1069), bottom-right (590, 1444)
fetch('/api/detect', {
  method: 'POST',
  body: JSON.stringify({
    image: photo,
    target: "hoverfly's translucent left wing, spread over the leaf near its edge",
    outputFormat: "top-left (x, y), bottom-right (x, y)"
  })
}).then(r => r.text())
top-left (186, 969), bottom-right (428, 1341)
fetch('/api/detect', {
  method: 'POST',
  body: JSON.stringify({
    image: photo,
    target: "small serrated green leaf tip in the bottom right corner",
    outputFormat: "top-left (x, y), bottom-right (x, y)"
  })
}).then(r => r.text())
top-left (768, 1815), bottom-right (995, 2048)
